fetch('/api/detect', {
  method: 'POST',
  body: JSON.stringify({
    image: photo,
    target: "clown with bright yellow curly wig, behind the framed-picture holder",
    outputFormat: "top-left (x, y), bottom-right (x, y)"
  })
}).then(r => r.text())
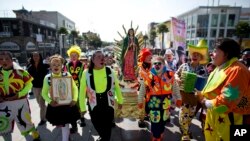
top-left (65, 45), bottom-right (86, 133)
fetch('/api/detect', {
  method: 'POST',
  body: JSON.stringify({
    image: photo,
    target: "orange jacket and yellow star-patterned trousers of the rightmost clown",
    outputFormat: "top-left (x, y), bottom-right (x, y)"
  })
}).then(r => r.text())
top-left (202, 58), bottom-right (250, 141)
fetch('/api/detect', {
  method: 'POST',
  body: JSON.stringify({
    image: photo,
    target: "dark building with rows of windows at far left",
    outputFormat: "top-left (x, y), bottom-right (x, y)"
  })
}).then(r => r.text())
top-left (0, 8), bottom-right (57, 64)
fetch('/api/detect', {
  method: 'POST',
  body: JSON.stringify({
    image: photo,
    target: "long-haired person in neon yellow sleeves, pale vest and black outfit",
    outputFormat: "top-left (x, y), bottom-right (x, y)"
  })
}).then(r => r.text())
top-left (79, 50), bottom-right (123, 141)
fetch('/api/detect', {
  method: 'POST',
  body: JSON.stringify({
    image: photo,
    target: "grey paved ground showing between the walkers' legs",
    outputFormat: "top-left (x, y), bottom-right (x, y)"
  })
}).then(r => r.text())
top-left (0, 96), bottom-right (204, 141)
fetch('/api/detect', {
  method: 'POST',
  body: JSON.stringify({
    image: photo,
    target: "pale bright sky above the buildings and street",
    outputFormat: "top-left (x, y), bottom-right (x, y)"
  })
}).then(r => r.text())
top-left (0, 0), bottom-right (250, 42)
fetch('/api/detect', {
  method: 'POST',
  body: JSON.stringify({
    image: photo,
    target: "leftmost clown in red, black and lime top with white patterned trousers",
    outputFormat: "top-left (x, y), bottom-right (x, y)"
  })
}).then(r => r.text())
top-left (0, 51), bottom-right (40, 141)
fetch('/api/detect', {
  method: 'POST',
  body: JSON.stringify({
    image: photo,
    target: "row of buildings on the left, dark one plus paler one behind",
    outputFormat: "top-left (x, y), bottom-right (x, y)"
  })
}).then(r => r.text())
top-left (0, 8), bottom-right (75, 64)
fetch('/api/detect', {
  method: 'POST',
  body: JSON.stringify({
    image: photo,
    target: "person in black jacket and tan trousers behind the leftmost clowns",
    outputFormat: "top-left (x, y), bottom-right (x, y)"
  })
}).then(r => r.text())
top-left (27, 51), bottom-right (49, 126)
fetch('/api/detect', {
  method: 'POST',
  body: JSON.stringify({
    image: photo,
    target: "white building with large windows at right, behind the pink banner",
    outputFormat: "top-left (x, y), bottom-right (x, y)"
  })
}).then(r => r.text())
top-left (177, 6), bottom-right (241, 50)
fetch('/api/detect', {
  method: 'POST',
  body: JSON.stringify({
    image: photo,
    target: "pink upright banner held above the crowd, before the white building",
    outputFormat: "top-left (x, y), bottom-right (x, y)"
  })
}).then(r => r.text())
top-left (171, 17), bottom-right (186, 51)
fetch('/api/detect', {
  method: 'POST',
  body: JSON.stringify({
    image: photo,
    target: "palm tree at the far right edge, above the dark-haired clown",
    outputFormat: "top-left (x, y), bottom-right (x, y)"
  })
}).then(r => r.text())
top-left (235, 21), bottom-right (250, 49)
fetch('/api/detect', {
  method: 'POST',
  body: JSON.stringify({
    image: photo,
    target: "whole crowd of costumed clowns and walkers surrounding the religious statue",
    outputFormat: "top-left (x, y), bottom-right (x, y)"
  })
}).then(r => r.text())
top-left (0, 36), bottom-right (250, 141)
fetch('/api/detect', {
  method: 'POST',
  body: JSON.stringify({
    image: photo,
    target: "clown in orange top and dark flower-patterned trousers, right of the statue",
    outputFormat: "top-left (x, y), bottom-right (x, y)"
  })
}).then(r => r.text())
top-left (140, 56), bottom-right (181, 141)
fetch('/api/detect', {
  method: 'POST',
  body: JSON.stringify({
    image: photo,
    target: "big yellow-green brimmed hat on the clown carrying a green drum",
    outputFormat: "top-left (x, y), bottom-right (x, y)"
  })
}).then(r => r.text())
top-left (188, 39), bottom-right (209, 64)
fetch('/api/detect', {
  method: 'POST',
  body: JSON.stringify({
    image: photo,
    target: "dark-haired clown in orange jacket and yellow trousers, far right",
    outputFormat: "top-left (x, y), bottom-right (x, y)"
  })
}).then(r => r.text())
top-left (197, 39), bottom-right (250, 141)
